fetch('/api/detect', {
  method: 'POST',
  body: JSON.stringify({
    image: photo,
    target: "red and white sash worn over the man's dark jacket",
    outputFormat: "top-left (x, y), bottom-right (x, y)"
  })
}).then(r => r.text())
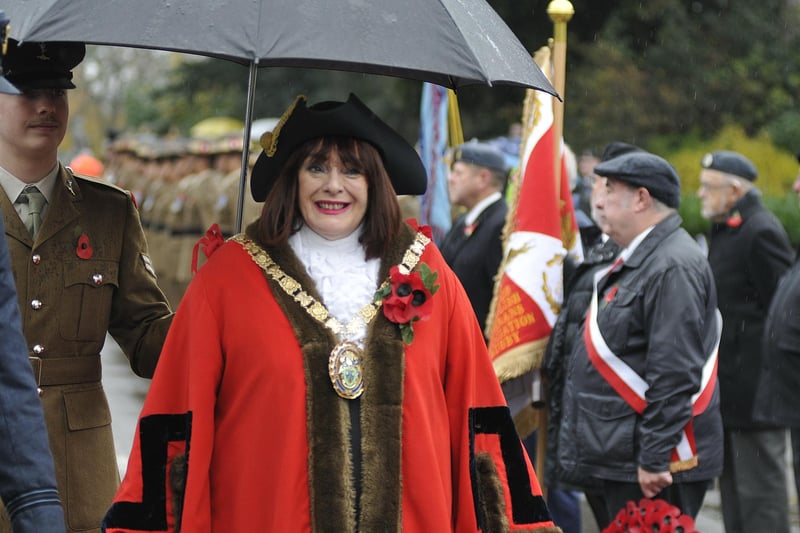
top-left (583, 260), bottom-right (722, 472)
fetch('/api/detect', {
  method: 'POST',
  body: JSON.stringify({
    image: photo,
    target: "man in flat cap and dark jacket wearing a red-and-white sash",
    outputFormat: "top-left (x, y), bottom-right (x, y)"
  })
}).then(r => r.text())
top-left (558, 151), bottom-right (722, 517)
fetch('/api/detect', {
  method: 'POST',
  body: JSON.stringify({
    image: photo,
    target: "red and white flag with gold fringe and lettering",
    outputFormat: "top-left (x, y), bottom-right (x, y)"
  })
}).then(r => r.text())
top-left (486, 47), bottom-right (582, 383)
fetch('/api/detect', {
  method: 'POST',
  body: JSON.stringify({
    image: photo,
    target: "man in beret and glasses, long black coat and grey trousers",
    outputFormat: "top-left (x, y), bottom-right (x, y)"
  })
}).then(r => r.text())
top-left (698, 150), bottom-right (793, 533)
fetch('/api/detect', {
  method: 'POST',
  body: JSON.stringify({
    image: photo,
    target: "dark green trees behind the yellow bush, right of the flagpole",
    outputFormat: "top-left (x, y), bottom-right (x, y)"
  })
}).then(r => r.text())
top-left (565, 0), bottom-right (800, 155)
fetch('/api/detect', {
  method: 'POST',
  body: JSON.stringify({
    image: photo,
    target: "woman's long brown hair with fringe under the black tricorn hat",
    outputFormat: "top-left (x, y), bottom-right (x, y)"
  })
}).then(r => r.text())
top-left (257, 137), bottom-right (403, 259)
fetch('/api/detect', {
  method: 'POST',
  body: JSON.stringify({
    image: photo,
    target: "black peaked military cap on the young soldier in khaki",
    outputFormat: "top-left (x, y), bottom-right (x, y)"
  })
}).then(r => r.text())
top-left (3, 39), bottom-right (86, 90)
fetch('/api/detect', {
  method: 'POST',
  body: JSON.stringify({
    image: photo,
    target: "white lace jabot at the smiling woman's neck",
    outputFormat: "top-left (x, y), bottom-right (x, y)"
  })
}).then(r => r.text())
top-left (289, 224), bottom-right (380, 345)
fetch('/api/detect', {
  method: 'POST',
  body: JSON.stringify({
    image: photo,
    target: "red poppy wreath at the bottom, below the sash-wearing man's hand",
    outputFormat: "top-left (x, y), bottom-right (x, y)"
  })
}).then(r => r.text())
top-left (603, 498), bottom-right (699, 533)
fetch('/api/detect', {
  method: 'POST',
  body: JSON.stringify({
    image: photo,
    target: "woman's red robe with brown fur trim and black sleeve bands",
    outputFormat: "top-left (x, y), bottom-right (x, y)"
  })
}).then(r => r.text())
top-left (104, 221), bottom-right (560, 533)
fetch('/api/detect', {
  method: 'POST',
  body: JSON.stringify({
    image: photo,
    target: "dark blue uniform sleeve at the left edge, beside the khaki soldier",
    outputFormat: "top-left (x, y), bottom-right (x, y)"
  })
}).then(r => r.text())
top-left (0, 213), bottom-right (65, 533)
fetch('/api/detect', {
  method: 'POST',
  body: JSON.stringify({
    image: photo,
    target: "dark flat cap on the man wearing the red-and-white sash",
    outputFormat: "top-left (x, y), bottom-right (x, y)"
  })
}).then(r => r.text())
top-left (594, 150), bottom-right (681, 207)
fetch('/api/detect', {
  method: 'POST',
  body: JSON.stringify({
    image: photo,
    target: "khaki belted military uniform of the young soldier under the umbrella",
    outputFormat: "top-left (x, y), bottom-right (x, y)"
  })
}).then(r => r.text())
top-left (0, 166), bottom-right (172, 533)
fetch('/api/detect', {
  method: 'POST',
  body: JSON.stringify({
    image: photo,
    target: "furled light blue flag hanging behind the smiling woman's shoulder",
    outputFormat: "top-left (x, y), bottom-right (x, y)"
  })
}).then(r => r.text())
top-left (419, 82), bottom-right (452, 244)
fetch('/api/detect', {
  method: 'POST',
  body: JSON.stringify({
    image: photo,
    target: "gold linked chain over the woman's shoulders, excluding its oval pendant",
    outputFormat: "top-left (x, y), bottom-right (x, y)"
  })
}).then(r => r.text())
top-left (231, 232), bottom-right (431, 337)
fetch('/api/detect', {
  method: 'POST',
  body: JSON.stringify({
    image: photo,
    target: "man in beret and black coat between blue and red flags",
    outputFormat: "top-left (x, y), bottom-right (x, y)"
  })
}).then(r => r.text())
top-left (440, 142), bottom-right (508, 329)
